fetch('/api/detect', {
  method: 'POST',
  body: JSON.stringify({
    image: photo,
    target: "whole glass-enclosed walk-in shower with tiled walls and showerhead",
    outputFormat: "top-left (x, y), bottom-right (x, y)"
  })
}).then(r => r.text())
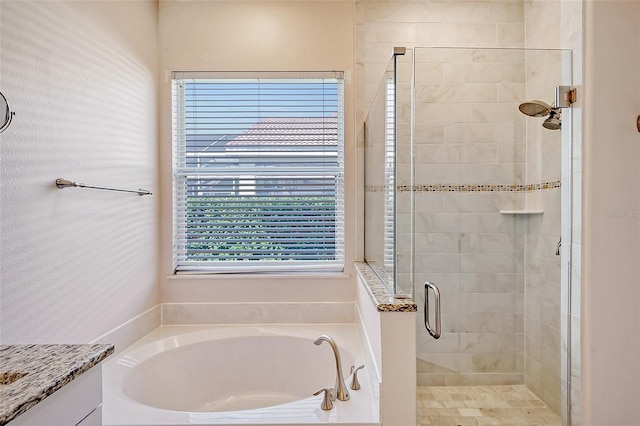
top-left (365, 48), bottom-right (573, 422)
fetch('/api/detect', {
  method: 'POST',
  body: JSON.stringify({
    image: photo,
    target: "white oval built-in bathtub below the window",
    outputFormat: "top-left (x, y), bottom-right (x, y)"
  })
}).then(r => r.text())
top-left (102, 324), bottom-right (380, 426)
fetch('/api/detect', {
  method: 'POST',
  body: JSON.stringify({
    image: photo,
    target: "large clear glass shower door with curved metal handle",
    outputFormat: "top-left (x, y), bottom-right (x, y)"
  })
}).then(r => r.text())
top-left (416, 48), bottom-right (571, 420)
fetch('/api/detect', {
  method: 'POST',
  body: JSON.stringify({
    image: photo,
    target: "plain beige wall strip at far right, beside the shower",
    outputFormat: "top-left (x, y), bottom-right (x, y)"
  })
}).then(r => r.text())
top-left (580, 1), bottom-right (640, 425)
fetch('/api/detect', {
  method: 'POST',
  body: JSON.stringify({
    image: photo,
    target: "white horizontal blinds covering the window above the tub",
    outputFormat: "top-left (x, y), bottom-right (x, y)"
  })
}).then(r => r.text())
top-left (173, 72), bottom-right (344, 273)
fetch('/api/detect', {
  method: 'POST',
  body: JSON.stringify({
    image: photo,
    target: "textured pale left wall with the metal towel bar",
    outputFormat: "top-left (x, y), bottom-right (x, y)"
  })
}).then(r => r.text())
top-left (0, 1), bottom-right (159, 344)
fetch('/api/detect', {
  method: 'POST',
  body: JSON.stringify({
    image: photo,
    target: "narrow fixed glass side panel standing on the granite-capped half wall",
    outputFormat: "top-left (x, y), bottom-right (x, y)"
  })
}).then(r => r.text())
top-left (365, 50), bottom-right (413, 297)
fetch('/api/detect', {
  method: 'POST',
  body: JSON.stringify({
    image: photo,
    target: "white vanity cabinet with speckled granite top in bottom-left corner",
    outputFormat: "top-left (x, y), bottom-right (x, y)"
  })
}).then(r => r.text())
top-left (0, 343), bottom-right (115, 426)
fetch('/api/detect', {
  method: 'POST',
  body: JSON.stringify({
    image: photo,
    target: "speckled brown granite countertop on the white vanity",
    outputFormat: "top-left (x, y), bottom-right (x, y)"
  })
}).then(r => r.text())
top-left (0, 344), bottom-right (114, 426)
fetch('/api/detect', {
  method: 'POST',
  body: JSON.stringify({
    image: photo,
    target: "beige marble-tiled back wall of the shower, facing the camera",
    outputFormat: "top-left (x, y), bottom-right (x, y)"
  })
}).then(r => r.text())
top-left (356, 0), bottom-right (526, 384)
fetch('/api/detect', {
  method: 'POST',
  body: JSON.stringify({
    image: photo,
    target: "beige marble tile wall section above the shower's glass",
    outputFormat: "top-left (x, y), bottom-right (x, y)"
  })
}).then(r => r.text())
top-left (356, 0), bottom-right (524, 124)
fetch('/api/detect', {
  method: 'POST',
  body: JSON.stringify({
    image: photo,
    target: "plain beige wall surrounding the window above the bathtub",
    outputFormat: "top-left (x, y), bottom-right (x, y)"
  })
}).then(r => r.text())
top-left (160, 1), bottom-right (356, 302)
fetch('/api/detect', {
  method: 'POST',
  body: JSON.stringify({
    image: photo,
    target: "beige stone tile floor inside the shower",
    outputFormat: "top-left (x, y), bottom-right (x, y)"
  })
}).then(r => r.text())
top-left (417, 385), bottom-right (561, 426)
